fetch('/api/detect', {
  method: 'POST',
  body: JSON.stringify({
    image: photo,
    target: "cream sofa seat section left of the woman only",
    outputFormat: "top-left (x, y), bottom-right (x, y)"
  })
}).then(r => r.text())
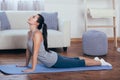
top-left (0, 29), bottom-right (28, 49)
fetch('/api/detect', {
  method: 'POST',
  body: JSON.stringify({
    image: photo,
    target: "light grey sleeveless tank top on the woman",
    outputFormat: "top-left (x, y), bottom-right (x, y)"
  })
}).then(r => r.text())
top-left (27, 32), bottom-right (58, 67)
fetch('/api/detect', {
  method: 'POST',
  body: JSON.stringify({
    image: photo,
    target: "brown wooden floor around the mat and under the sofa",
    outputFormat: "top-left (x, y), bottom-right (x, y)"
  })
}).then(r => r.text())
top-left (0, 42), bottom-right (120, 80)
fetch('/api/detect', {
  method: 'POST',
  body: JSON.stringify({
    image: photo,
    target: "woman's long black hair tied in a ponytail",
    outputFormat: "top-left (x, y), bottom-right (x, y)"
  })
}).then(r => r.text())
top-left (37, 14), bottom-right (49, 52)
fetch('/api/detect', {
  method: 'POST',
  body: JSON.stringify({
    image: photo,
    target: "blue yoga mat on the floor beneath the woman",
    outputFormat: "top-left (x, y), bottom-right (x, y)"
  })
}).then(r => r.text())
top-left (0, 64), bottom-right (112, 75)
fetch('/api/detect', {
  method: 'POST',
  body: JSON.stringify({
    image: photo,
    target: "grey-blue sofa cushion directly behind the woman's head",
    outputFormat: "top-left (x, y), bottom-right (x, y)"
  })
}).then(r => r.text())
top-left (41, 12), bottom-right (58, 30)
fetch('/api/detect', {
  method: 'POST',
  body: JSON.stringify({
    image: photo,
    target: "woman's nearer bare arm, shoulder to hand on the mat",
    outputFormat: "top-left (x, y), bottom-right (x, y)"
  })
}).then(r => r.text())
top-left (24, 32), bottom-right (42, 72)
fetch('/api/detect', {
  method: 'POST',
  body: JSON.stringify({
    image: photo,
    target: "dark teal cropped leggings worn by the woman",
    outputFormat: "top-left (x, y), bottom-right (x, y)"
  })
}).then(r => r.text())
top-left (52, 55), bottom-right (85, 68)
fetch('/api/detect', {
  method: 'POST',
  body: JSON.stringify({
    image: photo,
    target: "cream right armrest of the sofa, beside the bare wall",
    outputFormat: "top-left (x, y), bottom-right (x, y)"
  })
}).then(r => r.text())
top-left (58, 19), bottom-right (71, 47)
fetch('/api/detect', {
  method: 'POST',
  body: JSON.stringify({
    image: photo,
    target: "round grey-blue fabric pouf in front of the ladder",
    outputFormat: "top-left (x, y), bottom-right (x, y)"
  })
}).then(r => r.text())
top-left (82, 30), bottom-right (108, 56)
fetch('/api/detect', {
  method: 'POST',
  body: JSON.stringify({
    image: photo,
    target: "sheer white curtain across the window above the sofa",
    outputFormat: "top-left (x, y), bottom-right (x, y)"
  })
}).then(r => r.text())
top-left (0, 0), bottom-right (44, 10)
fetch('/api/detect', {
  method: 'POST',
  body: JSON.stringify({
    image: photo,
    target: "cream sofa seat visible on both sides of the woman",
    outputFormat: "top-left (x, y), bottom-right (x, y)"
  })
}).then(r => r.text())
top-left (0, 29), bottom-right (64, 49)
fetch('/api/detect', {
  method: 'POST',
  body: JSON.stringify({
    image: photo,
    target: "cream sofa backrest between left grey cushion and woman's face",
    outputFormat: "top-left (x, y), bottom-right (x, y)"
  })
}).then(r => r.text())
top-left (5, 11), bottom-right (39, 29)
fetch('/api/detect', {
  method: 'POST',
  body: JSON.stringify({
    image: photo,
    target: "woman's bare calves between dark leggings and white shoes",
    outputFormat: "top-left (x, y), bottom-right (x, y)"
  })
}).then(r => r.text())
top-left (79, 57), bottom-right (101, 66)
